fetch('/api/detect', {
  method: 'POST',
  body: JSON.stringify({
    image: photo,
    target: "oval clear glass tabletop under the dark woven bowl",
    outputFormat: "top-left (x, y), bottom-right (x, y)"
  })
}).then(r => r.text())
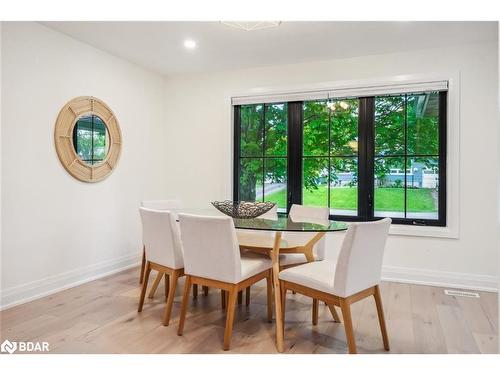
top-left (176, 208), bottom-right (348, 232)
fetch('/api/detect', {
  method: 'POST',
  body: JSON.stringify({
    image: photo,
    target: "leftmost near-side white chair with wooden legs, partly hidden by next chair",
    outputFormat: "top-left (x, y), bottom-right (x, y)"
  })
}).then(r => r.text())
top-left (138, 207), bottom-right (184, 325)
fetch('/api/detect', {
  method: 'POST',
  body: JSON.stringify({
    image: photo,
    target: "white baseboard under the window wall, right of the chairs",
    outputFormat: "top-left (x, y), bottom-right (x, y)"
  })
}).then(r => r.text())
top-left (382, 266), bottom-right (498, 292)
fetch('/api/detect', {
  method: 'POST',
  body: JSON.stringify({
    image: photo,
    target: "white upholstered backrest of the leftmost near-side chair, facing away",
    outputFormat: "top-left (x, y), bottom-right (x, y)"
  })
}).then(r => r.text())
top-left (139, 207), bottom-right (184, 269)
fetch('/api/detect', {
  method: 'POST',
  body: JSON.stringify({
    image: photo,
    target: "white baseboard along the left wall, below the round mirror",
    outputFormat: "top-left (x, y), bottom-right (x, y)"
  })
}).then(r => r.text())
top-left (0, 253), bottom-right (140, 311)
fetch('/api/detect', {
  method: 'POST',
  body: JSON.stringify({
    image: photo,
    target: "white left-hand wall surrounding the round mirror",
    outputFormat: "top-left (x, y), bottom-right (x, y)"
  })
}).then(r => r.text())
top-left (1, 22), bottom-right (166, 307)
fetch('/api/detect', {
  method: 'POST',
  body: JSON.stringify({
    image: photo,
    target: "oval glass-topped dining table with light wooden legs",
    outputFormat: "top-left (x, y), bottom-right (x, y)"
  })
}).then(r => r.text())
top-left (176, 208), bottom-right (348, 353)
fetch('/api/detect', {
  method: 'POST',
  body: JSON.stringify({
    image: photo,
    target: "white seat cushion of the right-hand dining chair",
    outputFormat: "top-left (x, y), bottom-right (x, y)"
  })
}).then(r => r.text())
top-left (279, 260), bottom-right (336, 294)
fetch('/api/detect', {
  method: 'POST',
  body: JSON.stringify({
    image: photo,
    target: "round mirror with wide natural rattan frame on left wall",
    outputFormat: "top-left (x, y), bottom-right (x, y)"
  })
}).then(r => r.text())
top-left (54, 96), bottom-right (122, 182)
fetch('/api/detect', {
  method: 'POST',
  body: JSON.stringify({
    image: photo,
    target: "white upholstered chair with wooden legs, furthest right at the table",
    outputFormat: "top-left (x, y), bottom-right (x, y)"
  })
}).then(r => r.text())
top-left (279, 219), bottom-right (391, 353)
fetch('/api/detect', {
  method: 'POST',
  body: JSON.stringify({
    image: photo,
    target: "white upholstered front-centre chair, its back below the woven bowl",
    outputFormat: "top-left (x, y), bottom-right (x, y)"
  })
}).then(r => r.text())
top-left (177, 214), bottom-right (272, 350)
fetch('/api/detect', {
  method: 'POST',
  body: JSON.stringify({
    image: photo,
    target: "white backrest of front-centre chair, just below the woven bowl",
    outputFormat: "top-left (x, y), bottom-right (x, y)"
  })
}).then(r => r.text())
top-left (179, 214), bottom-right (241, 283)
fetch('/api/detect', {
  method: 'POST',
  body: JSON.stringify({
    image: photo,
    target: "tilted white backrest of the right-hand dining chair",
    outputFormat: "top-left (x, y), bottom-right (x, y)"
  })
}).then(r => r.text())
top-left (333, 218), bottom-right (391, 297)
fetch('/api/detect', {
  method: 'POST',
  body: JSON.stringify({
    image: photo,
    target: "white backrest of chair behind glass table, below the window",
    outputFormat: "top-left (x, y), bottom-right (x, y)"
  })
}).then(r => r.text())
top-left (283, 204), bottom-right (330, 260)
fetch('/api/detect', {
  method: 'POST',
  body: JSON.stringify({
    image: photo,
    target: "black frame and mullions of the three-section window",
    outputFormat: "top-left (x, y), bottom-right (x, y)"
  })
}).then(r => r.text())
top-left (233, 91), bottom-right (448, 227)
